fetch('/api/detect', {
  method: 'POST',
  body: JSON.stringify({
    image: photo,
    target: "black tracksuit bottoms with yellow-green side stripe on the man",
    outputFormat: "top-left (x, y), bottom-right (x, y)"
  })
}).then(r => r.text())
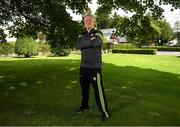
top-left (80, 67), bottom-right (109, 117)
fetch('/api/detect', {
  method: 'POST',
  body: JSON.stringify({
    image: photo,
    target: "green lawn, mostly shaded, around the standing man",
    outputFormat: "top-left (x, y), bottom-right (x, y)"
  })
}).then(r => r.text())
top-left (0, 54), bottom-right (180, 126)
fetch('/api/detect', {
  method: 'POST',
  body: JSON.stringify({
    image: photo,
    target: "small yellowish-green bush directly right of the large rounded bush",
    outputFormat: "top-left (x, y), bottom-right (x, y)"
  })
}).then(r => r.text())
top-left (39, 42), bottom-right (51, 55)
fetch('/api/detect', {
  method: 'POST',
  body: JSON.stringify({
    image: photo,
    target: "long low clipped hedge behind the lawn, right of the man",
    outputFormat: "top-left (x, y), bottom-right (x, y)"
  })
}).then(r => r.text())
top-left (112, 49), bottom-right (157, 55)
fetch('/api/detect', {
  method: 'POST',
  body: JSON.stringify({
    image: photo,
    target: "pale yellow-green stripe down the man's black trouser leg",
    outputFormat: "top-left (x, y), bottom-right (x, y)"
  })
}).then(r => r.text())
top-left (97, 73), bottom-right (109, 117)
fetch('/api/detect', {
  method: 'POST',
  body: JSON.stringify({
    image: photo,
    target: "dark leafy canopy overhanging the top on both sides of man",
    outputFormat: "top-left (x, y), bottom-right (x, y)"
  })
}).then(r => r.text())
top-left (0, 0), bottom-right (180, 46)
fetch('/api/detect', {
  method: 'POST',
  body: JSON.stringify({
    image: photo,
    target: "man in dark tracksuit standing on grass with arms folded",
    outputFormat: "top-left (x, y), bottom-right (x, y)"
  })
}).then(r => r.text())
top-left (75, 15), bottom-right (109, 120)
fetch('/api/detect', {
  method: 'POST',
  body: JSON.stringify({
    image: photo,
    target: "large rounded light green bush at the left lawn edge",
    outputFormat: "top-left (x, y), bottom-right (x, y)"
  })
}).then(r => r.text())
top-left (15, 37), bottom-right (39, 57)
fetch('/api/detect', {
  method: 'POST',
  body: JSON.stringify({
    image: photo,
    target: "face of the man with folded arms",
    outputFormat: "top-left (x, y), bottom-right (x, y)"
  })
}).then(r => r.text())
top-left (84, 16), bottom-right (94, 29)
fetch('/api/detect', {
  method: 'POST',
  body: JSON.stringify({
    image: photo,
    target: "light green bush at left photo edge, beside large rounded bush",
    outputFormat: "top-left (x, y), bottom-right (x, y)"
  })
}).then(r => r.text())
top-left (0, 43), bottom-right (14, 56)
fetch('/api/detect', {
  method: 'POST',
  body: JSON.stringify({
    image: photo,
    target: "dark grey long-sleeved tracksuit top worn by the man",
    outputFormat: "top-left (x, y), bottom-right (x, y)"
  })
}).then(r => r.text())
top-left (75, 29), bottom-right (102, 68)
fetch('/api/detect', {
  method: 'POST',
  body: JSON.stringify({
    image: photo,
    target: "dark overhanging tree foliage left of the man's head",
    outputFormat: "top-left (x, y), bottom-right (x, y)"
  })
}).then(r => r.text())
top-left (0, 0), bottom-right (84, 47)
